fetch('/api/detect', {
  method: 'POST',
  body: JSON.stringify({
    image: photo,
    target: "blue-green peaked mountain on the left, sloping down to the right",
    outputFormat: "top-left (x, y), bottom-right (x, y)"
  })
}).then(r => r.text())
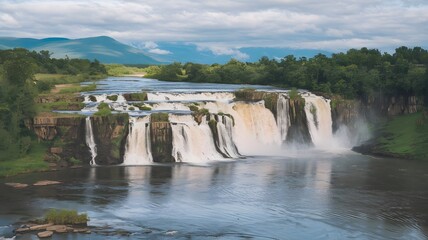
top-left (0, 36), bottom-right (160, 64)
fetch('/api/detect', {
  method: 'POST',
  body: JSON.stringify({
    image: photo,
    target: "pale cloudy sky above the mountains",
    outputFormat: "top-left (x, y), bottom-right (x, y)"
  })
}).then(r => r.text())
top-left (0, 0), bottom-right (428, 51)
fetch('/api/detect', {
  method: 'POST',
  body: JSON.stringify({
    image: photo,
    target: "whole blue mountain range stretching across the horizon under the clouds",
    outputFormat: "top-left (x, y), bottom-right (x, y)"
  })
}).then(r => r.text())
top-left (0, 36), bottom-right (331, 64)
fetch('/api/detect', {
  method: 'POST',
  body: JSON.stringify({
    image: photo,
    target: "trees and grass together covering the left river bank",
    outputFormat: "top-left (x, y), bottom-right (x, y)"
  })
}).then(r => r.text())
top-left (0, 49), bottom-right (106, 176)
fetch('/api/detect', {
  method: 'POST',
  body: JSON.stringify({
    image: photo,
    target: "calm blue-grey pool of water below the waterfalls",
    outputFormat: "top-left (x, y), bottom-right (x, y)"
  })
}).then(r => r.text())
top-left (0, 152), bottom-right (428, 239)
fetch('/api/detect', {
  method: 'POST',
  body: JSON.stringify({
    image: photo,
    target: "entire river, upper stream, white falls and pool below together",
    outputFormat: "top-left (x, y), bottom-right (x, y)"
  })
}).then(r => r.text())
top-left (0, 78), bottom-right (428, 240)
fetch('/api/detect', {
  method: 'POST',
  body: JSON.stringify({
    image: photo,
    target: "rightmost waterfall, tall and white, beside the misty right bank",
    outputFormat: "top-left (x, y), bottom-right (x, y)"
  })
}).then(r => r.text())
top-left (303, 93), bottom-right (333, 148)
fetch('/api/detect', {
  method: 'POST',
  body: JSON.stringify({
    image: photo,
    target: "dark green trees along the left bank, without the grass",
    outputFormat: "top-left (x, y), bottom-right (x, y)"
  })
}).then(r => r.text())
top-left (0, 49), bottom-right (106, 160)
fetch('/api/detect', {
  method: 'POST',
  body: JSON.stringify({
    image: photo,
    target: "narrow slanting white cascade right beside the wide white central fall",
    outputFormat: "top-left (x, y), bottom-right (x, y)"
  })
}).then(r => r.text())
top-left (216, 115), bottom-right (240, 158)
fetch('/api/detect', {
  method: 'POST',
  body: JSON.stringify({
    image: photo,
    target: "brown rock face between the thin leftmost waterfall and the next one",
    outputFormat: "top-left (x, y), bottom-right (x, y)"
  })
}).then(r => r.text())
top-left (91, 114), bottom-right (129, 165)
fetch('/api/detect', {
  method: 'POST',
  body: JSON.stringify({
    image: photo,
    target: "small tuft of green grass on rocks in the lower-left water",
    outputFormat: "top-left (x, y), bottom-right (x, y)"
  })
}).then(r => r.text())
top-left (45, 209), bottom-right (89, 225)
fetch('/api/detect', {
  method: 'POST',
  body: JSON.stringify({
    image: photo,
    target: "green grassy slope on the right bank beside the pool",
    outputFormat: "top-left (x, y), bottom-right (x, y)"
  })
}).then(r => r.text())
top-left (378, 113), bottom-right (428, 159)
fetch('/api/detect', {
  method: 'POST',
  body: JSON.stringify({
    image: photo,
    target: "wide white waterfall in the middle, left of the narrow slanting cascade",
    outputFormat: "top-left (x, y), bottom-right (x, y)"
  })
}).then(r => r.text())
top-left (169, 114), bottom-right (224, 163)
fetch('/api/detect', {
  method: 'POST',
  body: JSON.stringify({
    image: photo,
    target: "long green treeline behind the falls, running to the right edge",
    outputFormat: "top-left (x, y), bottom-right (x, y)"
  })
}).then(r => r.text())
top-left (147, 47), bottom-right (428, 103)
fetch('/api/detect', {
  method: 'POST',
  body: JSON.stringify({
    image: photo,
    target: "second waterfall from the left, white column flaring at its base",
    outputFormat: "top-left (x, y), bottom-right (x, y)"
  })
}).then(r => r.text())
top-left (123, 116), bottom-right (153, 165)
